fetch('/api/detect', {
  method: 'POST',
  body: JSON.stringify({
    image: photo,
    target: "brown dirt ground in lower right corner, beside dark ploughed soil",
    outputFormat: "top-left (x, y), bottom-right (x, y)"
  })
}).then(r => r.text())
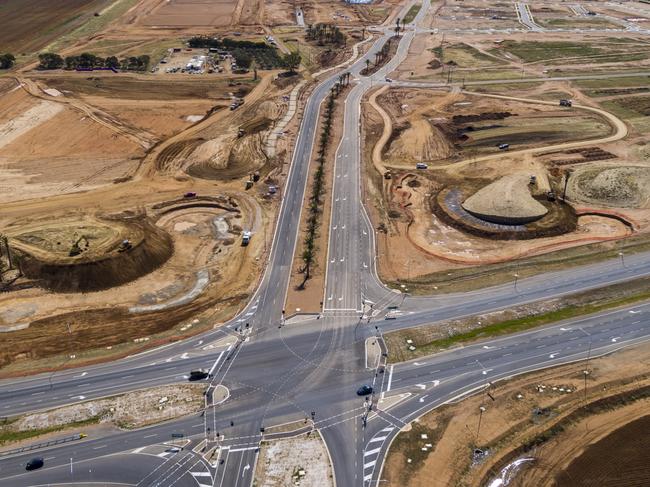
top-left (382, 345), bottom-right (650, 487)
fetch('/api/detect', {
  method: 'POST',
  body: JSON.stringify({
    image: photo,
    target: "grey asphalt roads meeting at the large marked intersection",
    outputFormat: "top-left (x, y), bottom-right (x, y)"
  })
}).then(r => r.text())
top-left (0, 1), bottom-right (650, 487)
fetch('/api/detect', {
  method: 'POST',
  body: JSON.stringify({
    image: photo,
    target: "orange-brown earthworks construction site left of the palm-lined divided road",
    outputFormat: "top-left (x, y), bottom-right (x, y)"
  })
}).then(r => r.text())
top-left (0, 1), bottom-right (326, 376)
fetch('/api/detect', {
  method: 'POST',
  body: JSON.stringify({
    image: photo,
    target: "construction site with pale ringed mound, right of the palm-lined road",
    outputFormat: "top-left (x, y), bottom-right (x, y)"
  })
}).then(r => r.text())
top-left (363, 18), bottom-right (650, 286)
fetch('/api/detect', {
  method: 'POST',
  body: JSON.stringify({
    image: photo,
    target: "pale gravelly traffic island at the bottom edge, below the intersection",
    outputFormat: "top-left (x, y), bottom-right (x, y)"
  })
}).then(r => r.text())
top-left (255, 433), bottom-right (334, 487)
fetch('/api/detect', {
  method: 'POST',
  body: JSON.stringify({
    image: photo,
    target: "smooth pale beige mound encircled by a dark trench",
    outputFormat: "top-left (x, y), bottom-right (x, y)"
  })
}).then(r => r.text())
top-left (462, 174), bottom-right (548, 225)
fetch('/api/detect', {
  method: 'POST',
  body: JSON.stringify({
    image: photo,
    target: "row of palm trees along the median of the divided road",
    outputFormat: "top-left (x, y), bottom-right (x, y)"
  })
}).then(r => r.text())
top-left (298, 73), bottom-right (350, 289)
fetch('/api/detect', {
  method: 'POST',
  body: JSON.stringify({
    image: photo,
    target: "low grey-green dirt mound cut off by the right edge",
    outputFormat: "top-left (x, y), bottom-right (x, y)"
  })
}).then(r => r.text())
top-left (567, 166), bottom-right (650, 208)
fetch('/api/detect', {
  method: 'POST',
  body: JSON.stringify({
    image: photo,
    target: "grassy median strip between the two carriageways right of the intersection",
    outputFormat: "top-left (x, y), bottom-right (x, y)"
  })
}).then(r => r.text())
top-left (385, 290), bottom-right (650, 360)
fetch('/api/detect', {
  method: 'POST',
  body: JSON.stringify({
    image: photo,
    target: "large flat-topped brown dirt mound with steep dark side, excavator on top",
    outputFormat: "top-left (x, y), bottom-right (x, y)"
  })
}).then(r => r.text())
top-left (10, 218), bottom-right (173, 292)
